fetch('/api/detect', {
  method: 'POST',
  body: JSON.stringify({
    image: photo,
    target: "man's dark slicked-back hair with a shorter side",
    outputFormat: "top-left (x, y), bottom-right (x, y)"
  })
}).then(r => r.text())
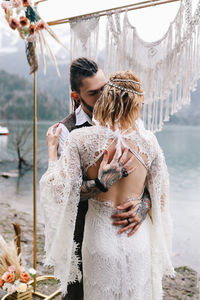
top-left (70, 57), bottom-right (99, 92)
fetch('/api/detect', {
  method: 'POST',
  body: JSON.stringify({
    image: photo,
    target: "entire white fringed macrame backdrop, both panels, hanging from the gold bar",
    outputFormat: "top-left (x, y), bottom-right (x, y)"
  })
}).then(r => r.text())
top-left (70, 0), bottom-right (200, 131)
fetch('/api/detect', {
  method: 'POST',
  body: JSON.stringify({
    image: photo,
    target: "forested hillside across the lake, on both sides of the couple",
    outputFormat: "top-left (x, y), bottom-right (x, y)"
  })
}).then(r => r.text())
top-left (0, 71), bottom-right (200, 125)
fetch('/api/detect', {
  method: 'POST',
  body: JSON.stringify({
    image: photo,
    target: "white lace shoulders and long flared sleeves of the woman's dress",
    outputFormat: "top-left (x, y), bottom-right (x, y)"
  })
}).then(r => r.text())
top-left (40, 126), bottom-right (174, 300)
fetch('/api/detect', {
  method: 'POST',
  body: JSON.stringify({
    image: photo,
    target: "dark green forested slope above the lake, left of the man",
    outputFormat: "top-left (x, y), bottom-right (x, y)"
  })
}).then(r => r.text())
top-left (0, 71), bottom-right (68, 120)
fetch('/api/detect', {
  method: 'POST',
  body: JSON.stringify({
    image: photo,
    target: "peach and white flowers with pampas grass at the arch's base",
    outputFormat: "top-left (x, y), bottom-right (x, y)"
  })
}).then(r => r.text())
top-left (0, 235), bottom-right (36, 300)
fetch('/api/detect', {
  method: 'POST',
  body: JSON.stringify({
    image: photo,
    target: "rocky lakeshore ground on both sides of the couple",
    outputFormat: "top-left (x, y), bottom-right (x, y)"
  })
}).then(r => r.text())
top-left (0, 203), bottom-right (200, 300)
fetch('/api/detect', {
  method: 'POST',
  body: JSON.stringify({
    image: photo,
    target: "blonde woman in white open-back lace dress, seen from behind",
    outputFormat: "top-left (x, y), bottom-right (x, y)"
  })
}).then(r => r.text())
top-left (40, 71), bottom-right (174, 300)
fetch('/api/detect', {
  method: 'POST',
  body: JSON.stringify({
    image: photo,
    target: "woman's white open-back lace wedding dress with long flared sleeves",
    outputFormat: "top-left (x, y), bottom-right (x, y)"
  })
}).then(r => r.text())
top-left (40, 126), bottom-right (174, 300)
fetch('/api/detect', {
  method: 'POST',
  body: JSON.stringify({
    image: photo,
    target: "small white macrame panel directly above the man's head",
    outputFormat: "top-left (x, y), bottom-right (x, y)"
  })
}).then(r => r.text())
top-left (70, 16), bottom-right (99, 61)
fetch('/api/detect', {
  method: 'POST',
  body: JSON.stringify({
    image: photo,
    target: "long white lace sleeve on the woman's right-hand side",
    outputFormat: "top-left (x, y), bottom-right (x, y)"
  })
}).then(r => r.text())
top-left (147, 136), bottom-right (174, 276)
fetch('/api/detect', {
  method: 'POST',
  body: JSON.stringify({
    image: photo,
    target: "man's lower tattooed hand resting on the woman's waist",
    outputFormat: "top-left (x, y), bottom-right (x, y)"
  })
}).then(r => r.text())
top-left (112, 190), bottom-right (151, 237)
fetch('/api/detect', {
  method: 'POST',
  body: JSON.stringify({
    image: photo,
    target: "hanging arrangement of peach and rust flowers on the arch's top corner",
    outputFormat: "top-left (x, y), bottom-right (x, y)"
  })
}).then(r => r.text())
top-left (1, 0), bottom-right (66, 75)
